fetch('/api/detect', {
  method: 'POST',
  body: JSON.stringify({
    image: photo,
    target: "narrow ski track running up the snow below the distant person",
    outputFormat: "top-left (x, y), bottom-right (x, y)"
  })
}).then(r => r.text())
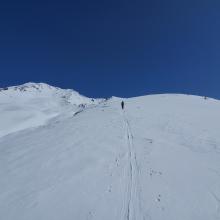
top-left (123, 111), bottom-right (146, 220)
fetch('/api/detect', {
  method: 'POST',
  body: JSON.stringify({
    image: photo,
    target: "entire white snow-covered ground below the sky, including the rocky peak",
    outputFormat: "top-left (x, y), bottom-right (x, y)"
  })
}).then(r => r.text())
top-left (0, 83), bottom-right (220, 220)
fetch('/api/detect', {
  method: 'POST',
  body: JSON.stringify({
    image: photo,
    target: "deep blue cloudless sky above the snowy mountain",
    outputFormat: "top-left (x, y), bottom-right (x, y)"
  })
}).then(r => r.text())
top-left (0, 0), bottom-right (220, 99)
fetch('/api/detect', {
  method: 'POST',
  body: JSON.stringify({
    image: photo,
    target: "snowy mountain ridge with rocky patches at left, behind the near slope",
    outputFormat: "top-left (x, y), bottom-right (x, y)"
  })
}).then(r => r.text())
top-left (0, 83), bottom-right (101, 137)
